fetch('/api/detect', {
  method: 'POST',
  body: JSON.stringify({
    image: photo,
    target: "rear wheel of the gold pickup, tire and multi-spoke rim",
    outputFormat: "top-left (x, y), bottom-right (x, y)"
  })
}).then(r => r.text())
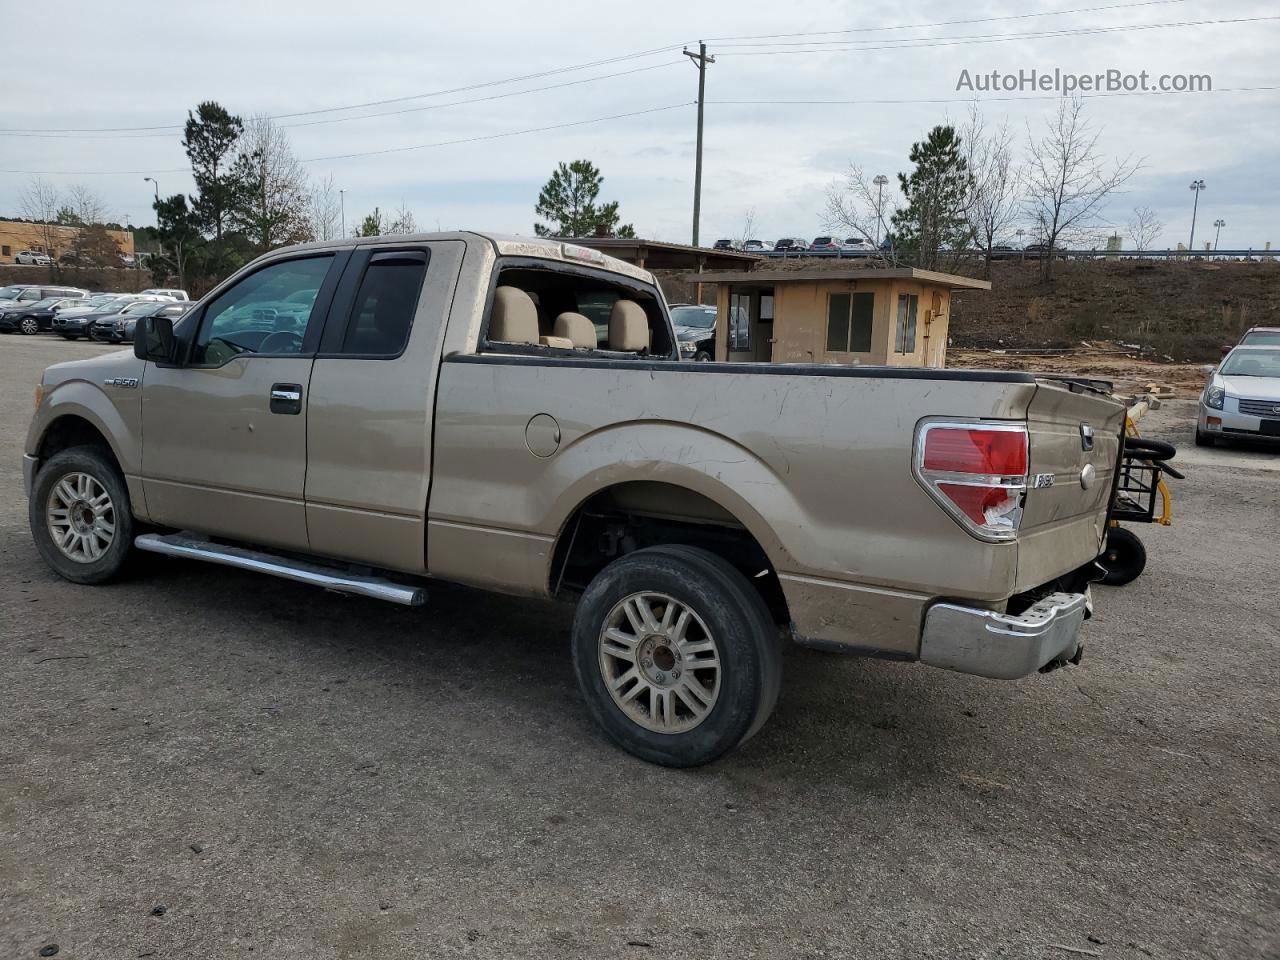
top-left (573, 545), bottom-right (782, 767)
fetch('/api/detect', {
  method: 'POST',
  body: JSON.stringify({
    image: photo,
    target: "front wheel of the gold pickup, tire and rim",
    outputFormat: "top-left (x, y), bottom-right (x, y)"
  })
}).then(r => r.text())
top-left (27, 447), bottom-right (133, 584)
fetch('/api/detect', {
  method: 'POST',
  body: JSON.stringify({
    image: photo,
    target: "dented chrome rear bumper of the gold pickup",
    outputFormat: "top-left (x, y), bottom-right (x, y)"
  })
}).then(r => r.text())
top-left (920, 590), bottom-right (1093, 680)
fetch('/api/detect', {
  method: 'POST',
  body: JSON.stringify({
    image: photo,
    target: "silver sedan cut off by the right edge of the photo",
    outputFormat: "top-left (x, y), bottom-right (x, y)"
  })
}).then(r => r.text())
top-left (1196, 346), bottom-right (1280, 447)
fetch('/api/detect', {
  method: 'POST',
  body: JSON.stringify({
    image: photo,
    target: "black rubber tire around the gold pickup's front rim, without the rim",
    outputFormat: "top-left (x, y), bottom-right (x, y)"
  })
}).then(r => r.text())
top-left (27, 447), bottom-right (133, 584)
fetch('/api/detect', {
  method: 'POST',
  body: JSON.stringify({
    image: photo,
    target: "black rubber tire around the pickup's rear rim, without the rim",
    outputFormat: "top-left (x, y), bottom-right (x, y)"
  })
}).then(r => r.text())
top-left (573, 545), bottom-right (782, 767)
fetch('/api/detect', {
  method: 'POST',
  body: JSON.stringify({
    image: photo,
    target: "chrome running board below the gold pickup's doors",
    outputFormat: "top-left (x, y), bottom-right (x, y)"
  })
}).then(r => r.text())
top-left (133, 534), bottom-right (426, 607)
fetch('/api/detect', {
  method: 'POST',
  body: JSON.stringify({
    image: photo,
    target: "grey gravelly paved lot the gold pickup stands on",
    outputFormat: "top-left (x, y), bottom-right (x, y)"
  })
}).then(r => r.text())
top-left (0, 337), bottom-right (1280, 960)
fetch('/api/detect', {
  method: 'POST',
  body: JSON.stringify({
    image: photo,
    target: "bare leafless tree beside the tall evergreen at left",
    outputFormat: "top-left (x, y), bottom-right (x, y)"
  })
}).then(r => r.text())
top-left (234, 116), bottom-right (312, 251)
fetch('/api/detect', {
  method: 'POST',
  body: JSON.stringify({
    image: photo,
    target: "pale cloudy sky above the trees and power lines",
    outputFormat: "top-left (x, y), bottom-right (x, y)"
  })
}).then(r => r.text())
top-left (0, 0), bottom-right (1280, 248)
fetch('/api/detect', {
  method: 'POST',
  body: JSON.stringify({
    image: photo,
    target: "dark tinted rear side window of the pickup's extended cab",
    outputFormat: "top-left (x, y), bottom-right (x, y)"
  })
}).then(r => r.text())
top-left (340, 250), bottom-right (426, 357)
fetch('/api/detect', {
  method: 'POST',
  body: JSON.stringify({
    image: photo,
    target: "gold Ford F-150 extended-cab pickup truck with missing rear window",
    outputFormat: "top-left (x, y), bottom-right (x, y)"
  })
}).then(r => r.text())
top-left (24, 233), bottom-right (1124, 765)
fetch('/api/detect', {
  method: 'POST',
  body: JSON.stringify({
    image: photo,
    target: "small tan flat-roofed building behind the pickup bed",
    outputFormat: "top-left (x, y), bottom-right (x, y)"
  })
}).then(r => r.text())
top-left (699, 268), bottom-right (991, 367)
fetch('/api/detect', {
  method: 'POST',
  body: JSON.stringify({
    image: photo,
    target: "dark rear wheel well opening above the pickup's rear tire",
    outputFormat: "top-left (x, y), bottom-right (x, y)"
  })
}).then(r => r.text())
top-left (550, 480), bottom-right (790, 623)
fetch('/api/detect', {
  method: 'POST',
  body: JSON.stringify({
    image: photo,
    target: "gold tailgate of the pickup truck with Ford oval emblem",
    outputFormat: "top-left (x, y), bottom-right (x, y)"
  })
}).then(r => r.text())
top-left (1015, 380), bottom-right (1125, 591)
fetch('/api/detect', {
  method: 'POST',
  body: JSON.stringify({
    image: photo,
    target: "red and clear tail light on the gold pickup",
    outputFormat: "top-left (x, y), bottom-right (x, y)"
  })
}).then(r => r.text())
top-left (913, 421), bottom-right (1028, 541)
